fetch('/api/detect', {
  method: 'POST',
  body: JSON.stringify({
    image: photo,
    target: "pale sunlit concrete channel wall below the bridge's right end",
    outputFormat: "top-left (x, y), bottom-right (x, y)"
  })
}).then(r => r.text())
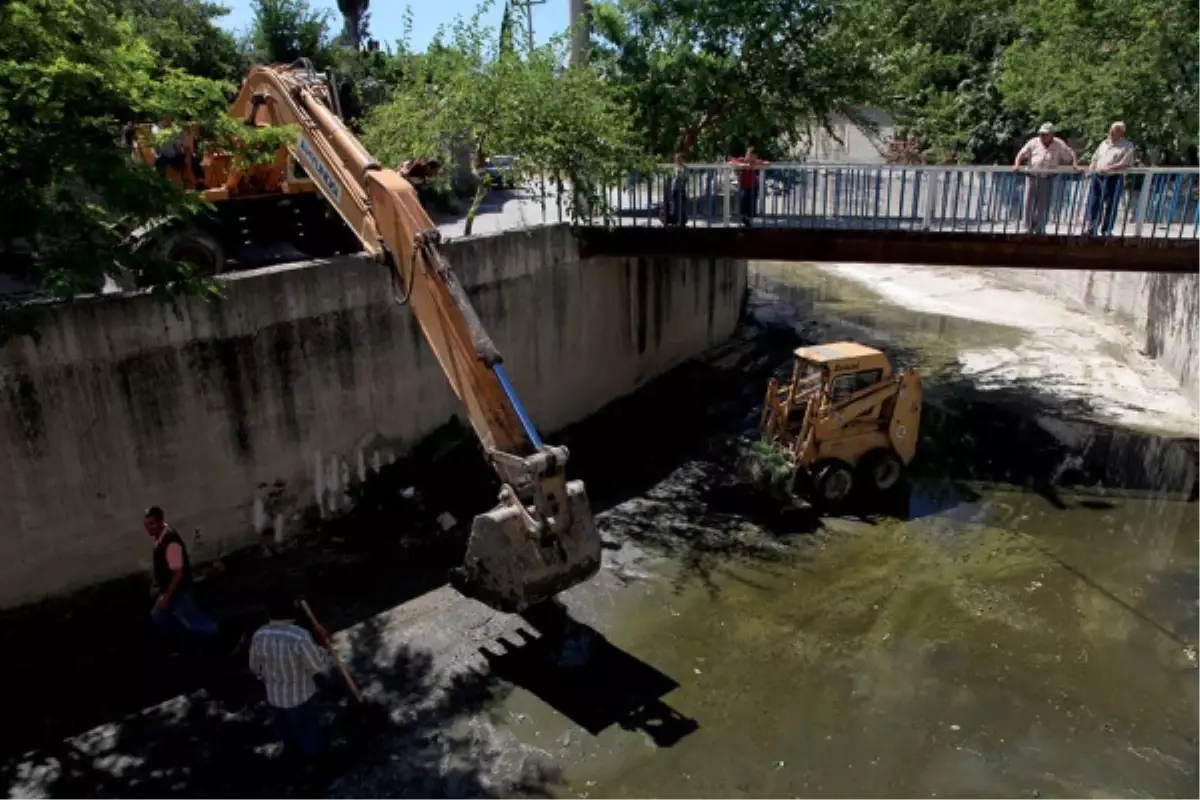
top-left (1004, 270), bottom-right (1200, 407)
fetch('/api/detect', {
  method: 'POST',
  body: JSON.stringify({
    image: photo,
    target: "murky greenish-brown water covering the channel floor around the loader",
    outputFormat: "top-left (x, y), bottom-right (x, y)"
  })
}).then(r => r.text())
top-left (492, 265), bottom-right (1200, 800)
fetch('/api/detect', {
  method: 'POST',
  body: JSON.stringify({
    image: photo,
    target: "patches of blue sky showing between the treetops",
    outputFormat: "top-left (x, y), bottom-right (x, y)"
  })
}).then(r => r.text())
top-left (218, 0), bottom-right (569, 50)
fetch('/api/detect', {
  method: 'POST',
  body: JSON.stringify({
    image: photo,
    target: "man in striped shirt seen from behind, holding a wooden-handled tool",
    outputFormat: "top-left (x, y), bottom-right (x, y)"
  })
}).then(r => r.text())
top-left (250, 588), bottom-right (329, 756)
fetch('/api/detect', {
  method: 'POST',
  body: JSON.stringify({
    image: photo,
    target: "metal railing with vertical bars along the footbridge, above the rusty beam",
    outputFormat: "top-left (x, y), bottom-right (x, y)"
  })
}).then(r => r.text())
top-left (585, 164), bottom-right (1200, 239)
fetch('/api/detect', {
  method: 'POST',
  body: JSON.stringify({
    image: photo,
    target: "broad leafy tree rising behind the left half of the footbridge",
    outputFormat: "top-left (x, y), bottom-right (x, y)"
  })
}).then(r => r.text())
top-left (592, 0), bottom-right (876, 157)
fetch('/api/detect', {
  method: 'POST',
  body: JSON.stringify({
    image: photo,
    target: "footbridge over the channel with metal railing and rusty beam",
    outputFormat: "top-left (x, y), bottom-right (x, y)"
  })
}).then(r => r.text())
top-left (580, 164), bottom-right (1200, 272)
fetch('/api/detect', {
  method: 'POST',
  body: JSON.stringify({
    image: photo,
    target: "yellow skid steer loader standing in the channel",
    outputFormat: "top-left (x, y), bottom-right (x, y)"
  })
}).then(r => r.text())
top-left (760, 342), bottom-right (922, 507)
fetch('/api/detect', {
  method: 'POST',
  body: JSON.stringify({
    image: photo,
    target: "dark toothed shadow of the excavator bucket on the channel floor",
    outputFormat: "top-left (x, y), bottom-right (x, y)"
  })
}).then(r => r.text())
top-left (480, 601), bottom-right (700, 747)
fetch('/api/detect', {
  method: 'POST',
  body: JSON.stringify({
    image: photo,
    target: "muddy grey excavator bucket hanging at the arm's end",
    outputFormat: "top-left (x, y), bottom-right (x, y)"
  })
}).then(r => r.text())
top-left (451, 481), bottom-right (601, 614)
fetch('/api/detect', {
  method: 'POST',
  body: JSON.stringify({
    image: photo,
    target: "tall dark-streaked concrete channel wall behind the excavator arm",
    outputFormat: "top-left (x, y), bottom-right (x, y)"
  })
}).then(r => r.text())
top-left (0, 227), bottom-right (746, 606)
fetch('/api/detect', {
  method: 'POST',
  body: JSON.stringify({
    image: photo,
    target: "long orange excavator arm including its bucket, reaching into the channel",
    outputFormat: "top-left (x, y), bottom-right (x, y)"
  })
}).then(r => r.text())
top-left (230, 60), bottom-right (601, 612)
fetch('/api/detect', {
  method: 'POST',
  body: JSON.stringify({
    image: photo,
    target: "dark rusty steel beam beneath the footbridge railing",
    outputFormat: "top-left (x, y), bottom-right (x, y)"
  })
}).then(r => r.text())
top-left (576, 227), bottom-right (1200, 272)
